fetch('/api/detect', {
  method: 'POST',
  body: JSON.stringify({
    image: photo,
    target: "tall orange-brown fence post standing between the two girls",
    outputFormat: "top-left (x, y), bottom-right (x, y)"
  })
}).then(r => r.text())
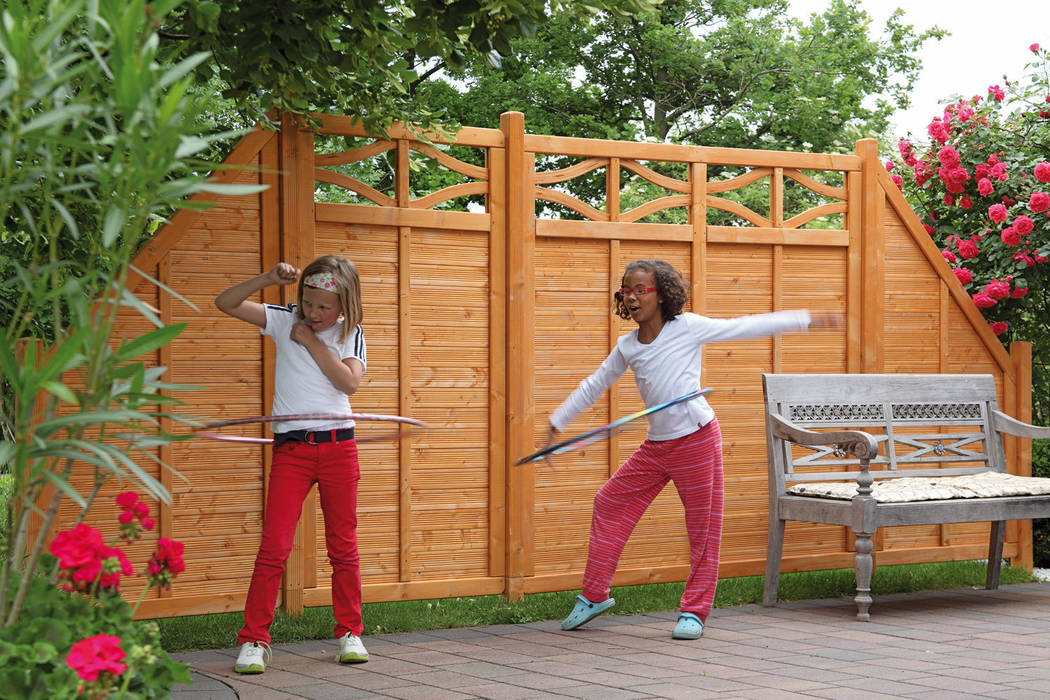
top-left (500, 112), bottom-right (536, 600)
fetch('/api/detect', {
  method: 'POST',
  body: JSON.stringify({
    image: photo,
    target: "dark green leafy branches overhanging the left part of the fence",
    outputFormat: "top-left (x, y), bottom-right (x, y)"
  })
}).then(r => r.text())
top-left (162, 0), bottom-right (659, 129)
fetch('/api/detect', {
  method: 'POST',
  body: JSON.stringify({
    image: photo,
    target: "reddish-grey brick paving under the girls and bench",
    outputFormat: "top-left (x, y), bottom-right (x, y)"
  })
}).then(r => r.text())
top-left (172, 582), bottom-right (1050, 700)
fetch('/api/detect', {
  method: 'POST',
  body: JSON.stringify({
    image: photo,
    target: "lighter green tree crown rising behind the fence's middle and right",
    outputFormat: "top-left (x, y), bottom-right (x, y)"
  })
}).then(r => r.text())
top-left (420, 0), bottom-right (942, 150)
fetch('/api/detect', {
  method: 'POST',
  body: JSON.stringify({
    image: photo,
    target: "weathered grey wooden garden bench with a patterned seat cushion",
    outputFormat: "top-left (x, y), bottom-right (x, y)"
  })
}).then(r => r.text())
top-left (762, 375), bottom-right (1050, 620)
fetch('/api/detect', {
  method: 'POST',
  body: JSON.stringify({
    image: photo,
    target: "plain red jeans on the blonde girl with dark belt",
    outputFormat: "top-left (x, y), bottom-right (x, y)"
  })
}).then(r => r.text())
top-left (237, 440), bottom-right (363, 643)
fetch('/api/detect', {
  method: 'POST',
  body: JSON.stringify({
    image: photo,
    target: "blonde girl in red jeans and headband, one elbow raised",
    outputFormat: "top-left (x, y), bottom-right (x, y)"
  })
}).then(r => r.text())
top-left (215, 255), bottom-right (369, 674)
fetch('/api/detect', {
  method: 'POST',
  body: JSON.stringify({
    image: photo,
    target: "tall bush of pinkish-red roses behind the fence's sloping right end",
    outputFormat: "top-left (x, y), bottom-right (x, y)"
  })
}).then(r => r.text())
top-left (887, 44), bottom-right (1050, 425)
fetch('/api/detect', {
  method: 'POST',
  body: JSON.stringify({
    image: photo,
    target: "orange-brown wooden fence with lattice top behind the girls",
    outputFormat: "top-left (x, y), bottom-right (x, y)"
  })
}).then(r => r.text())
top-left (45, 112), bottom-right (1031, 617)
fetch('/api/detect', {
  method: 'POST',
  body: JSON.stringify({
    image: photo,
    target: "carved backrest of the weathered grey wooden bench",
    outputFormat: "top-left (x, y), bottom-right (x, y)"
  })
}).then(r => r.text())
top-left (762, 375), bottom-right (1006, 493)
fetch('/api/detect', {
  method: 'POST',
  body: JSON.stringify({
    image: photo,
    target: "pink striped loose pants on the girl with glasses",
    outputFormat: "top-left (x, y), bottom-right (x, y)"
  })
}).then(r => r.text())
top-left (583, 420), bottom-right (723, 620)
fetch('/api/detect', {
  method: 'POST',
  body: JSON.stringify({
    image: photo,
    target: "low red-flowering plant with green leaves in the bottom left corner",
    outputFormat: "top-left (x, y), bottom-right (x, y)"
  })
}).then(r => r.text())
top-left (0, 492), bottom-right (190, 699)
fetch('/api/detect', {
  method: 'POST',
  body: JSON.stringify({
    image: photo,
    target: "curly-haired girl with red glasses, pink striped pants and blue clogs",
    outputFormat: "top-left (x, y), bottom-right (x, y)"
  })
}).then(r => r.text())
top-left (544, 259), bottom-right (842, 639)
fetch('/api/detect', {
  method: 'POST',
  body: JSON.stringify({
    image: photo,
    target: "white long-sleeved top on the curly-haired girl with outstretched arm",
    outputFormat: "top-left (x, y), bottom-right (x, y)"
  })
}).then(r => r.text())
top-left (550, 311), bottom-right (810, 440)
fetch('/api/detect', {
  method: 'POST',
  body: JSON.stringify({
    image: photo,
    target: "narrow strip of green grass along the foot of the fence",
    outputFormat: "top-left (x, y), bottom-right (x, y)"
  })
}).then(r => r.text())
top-left (156, 561), bottom-right (1034, 652)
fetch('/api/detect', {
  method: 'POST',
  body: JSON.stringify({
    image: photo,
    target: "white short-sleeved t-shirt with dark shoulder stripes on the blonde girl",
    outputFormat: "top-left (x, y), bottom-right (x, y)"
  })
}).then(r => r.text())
top-left (260, 303), bottom-right (369, 432)
